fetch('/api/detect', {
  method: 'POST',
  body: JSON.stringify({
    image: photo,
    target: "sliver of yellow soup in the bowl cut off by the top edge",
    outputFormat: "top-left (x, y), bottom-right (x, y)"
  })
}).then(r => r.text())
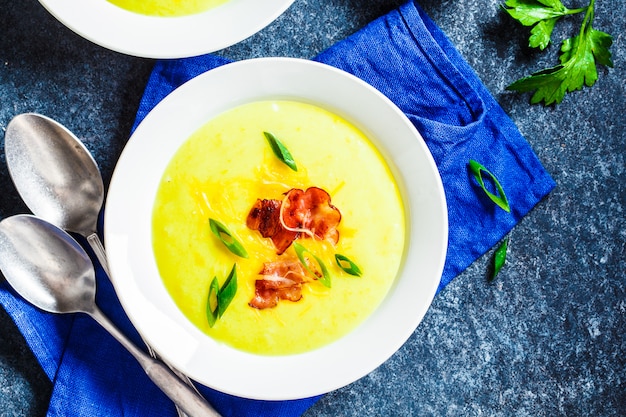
top-left (108, 0), bottom-right (228, 16)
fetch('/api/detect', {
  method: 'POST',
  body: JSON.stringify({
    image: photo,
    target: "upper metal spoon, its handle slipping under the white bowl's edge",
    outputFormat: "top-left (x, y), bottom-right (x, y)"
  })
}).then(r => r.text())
top-left (4, 113), bottom-right (110, 276)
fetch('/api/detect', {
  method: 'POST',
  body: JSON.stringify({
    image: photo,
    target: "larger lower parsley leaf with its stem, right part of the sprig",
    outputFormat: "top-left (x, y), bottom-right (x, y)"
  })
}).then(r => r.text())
top-left (507, 0), bottom-right (613, 105)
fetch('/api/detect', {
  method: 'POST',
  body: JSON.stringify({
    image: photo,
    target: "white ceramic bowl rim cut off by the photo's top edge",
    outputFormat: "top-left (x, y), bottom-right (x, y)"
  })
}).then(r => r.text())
top-left (40, 0), bottom-right (293, 58)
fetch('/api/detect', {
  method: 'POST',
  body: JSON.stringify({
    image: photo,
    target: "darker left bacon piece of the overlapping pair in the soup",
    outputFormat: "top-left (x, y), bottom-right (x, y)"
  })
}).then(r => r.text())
top-left (246, 199), bottom-right (298, 255)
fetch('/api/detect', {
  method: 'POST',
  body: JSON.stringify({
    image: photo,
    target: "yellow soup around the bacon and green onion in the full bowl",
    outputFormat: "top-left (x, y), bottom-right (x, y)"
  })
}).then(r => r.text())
top-left (152, 101), bottom-right (405, 355)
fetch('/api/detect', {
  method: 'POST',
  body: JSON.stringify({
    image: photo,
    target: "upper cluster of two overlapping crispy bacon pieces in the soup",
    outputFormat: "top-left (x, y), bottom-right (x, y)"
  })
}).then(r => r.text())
top-left (246, 187), bottom-right (341, 255)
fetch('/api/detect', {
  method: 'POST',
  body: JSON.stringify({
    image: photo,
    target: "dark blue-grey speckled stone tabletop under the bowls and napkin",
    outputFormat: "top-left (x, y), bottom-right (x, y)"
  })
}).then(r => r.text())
top-left (0, 0), bottom-right (626, 417)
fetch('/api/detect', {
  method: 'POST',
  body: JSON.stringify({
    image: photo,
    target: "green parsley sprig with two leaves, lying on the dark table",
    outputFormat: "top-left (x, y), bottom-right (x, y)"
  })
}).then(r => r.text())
top-left (503, 0), bottom-right (613, 105)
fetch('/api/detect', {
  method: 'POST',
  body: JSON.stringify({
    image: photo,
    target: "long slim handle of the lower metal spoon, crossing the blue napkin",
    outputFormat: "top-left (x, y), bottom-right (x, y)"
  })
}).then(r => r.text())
top-left (88, 306), bottom-right (221, 417)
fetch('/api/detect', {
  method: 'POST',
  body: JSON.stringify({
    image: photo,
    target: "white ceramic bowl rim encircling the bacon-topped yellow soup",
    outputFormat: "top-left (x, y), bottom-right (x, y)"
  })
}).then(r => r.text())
top-left (105, 58), bottom-right (448, 400)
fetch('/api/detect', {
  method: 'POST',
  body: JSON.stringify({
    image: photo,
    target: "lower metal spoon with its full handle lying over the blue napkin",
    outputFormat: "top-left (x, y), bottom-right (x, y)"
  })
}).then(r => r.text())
top-left (0, 214), bottom-right (219, 417)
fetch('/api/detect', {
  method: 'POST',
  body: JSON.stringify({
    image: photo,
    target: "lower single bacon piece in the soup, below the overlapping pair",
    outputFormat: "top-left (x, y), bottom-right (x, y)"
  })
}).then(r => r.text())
top-left (248, 260), bottom-right (306, 310)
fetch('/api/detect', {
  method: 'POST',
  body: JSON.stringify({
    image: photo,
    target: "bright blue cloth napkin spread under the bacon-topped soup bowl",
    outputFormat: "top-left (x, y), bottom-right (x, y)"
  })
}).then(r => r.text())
top-left (0, 1), bottom-right (555, 417)
